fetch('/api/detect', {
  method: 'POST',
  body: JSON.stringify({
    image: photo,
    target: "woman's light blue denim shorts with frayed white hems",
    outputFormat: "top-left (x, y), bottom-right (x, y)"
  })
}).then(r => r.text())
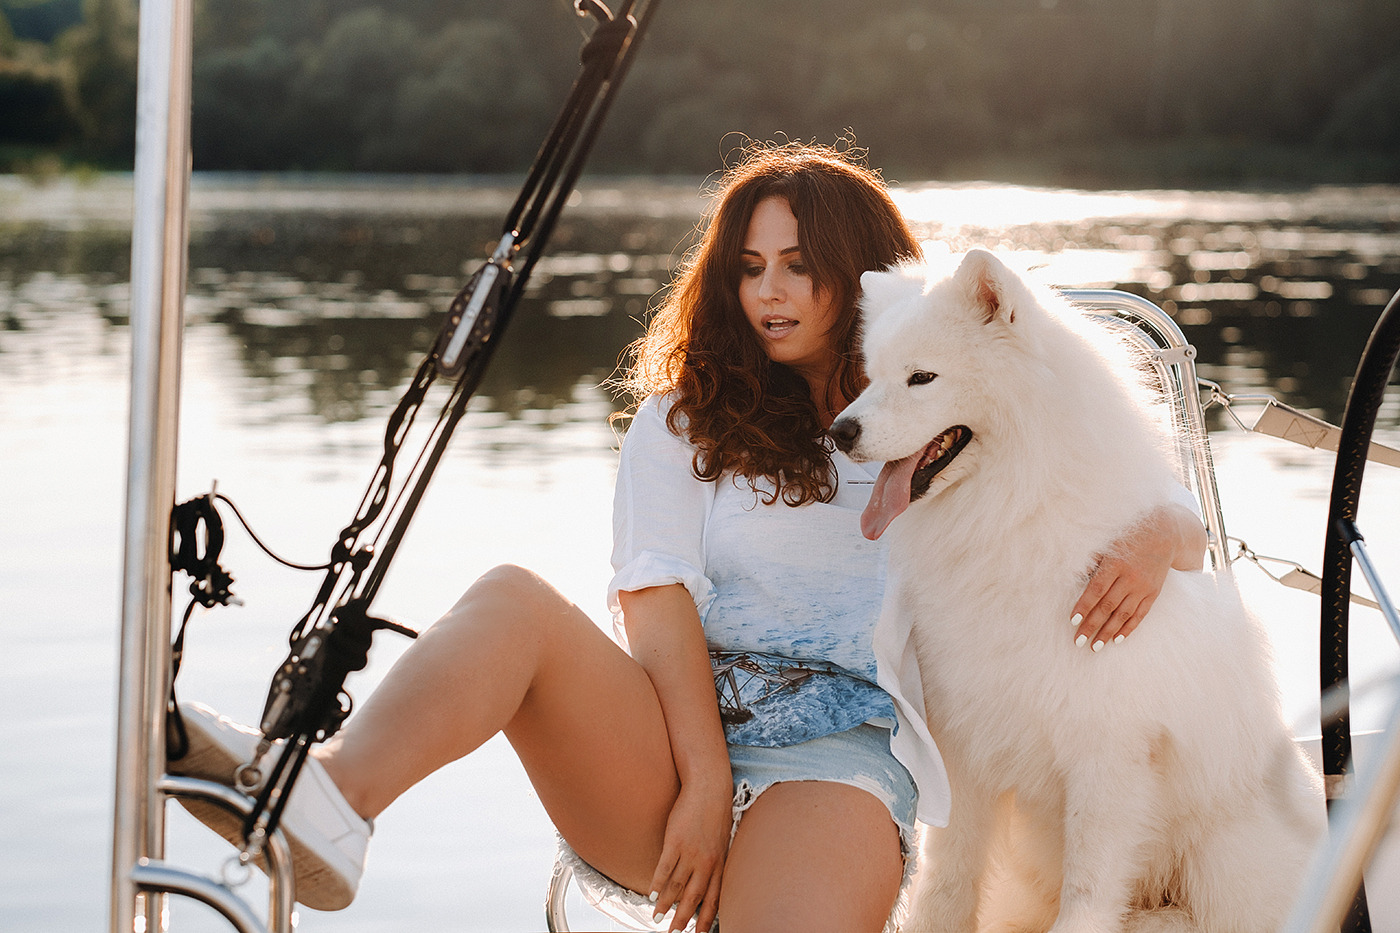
top-left (554, 724), bottom-right (918, 930)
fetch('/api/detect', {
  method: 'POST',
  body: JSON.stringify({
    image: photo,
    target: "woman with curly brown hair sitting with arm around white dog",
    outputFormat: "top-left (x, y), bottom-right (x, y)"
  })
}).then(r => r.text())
top-left (181, 146), bottom-right (1204, 933)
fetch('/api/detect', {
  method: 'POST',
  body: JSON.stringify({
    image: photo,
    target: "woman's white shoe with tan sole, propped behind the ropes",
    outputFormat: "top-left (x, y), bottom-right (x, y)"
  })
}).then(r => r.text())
top-left (169, 703), bottom-right (374, 911)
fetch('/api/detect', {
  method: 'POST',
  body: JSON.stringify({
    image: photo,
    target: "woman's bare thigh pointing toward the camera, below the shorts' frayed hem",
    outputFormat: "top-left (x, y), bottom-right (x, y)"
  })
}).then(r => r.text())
top-left (720, 780), bottom-right (904, 933)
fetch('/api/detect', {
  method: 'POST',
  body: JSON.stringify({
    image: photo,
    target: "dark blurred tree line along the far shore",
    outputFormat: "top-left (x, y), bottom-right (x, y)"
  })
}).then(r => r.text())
top-left (0, 0), bottom-right (1400, 182)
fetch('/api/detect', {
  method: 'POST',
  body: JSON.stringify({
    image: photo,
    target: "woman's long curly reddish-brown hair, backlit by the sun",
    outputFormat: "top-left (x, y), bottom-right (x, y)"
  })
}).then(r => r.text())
top-left (623, 143), bottom-right (918, 506)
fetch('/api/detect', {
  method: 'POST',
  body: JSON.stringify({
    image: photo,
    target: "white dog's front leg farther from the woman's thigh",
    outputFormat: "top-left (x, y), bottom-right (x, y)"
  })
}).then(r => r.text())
top-left (1051, 742), bottom-right (1161, 933)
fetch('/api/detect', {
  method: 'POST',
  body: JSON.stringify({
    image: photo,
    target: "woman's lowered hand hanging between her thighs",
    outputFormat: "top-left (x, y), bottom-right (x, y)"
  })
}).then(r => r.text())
top-left (651, 776), bottom-right (734, 933)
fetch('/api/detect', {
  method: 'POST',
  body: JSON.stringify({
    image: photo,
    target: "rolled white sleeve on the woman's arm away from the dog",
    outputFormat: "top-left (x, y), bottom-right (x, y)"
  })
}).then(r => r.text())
top-left (608, 396), bottom-right (714, 624)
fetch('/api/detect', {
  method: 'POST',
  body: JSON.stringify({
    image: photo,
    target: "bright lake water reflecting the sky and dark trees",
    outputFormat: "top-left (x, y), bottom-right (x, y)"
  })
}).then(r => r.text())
top-left (0, 177), bottom-right (1400, 933)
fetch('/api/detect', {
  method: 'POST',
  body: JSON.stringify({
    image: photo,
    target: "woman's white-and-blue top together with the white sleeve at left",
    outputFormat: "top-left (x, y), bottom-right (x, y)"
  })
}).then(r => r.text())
top-left (609, 399), bottom-right (896, 745)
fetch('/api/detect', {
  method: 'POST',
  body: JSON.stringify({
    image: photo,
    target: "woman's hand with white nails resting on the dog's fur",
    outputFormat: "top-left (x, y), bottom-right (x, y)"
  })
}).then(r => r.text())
top-left (1070, 504), bottom-right (1205, 651)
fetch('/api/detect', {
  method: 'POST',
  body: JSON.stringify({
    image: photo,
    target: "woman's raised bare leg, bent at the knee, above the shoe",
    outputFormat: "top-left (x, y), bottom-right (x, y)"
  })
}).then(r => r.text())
top-left (316, 567), bottom-right (680, 892)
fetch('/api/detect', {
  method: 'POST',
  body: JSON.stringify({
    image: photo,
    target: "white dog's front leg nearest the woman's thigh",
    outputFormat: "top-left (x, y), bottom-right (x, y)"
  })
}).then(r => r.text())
top-left (903, 782), bottom-right (995, 933)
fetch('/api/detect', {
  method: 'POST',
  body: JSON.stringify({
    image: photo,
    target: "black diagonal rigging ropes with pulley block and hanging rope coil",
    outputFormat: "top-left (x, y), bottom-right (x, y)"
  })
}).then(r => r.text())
top-left (167, 0), bottom-right (659, 863)
